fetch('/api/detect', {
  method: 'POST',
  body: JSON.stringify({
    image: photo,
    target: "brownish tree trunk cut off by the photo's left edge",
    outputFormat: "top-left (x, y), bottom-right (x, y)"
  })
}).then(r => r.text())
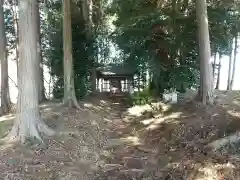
top-left (0, 0), bottom-right (11, 113)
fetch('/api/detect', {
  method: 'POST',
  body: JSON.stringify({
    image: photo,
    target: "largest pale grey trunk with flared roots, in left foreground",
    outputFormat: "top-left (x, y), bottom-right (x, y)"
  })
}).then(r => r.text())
top-left (8, 0), bottom-right (54, 143)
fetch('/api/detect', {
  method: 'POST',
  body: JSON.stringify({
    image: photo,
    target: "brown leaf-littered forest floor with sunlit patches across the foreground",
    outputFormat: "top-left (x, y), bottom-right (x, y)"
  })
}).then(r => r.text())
top-left (0, 93), bottom-right (240, 180)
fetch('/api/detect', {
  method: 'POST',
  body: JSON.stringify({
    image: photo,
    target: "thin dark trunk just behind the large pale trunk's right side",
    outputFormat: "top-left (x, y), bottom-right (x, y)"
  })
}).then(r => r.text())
top-left (36, 3), bottom-right (46, 103)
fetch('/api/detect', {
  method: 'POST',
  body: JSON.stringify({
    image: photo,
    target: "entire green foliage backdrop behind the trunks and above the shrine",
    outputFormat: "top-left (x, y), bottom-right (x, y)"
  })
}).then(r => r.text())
top-left (5, 0), bottom-right (240, 100)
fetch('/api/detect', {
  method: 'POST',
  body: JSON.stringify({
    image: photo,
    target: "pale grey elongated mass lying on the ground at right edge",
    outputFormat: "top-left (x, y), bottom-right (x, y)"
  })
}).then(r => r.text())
top-left (207, 132), bottom-right (240, 151)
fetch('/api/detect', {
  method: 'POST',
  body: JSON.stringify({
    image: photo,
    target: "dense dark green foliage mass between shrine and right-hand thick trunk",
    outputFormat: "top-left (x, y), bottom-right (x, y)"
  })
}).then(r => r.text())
top-left (109, 0), bottom-right (197, 94)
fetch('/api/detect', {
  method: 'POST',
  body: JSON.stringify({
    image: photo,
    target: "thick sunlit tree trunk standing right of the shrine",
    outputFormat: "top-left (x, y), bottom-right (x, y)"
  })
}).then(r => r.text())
top-left (196, 0), bottom-right (213, 105)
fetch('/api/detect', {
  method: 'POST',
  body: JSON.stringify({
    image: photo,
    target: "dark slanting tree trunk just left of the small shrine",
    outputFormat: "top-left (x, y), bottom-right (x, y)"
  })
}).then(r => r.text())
top-left (82, 0), bottom-right (97, 92)
